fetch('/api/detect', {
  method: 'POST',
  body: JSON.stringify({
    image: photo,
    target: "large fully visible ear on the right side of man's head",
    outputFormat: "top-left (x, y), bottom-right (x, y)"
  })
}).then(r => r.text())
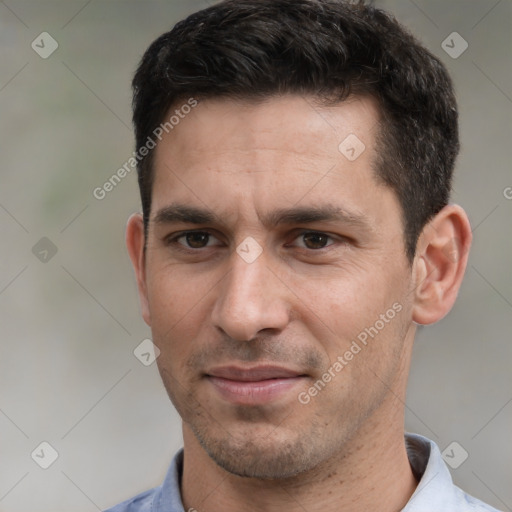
top-left (412, 205), bottom-right (472, 325)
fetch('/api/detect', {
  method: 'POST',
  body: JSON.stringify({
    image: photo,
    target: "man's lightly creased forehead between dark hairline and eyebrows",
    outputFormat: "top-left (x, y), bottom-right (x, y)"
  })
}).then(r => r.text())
top-left (152, 95), bottom-right (394, 227)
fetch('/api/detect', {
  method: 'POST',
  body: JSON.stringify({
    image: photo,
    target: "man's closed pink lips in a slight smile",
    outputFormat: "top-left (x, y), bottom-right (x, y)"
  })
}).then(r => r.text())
top-left (205, 365), bottom-right (307, 405)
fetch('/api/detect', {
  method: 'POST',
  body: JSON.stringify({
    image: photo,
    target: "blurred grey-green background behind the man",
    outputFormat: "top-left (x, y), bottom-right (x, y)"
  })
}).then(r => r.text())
top-left (0, 0), bottom-right (512, 512)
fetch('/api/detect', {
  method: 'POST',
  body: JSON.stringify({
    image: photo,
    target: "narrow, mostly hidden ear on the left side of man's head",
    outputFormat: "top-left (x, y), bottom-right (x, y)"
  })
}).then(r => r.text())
top-left (126, 213), bottom-right (151, 326)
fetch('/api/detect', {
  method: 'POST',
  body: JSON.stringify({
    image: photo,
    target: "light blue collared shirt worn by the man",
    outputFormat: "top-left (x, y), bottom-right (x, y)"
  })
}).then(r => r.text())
top-left (105, 434), bottom-right (499, 512)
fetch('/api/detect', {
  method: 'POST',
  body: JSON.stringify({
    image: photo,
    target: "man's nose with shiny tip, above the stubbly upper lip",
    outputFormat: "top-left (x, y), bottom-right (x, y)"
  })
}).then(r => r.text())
top-left (212, 247), bottom-right (290, 341)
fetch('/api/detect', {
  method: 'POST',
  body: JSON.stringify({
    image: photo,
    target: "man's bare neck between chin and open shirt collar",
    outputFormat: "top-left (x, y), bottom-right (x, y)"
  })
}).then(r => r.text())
top-left (181, 403), bottom-right (417, 512)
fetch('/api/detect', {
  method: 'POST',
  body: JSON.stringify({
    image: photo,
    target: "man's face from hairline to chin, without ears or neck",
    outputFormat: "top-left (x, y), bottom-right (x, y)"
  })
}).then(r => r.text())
top-left (137, 96), bottom-right (414, 478)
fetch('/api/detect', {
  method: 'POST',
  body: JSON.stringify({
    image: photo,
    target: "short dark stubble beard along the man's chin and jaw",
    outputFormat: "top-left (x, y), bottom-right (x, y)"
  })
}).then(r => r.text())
top-left (159, 318), bottom-right (410, 482)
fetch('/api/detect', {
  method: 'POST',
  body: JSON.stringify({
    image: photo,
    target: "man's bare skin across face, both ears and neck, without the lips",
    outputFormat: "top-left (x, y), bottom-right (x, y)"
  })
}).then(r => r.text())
top-left (127, 95), bottom-right (471, 512)
